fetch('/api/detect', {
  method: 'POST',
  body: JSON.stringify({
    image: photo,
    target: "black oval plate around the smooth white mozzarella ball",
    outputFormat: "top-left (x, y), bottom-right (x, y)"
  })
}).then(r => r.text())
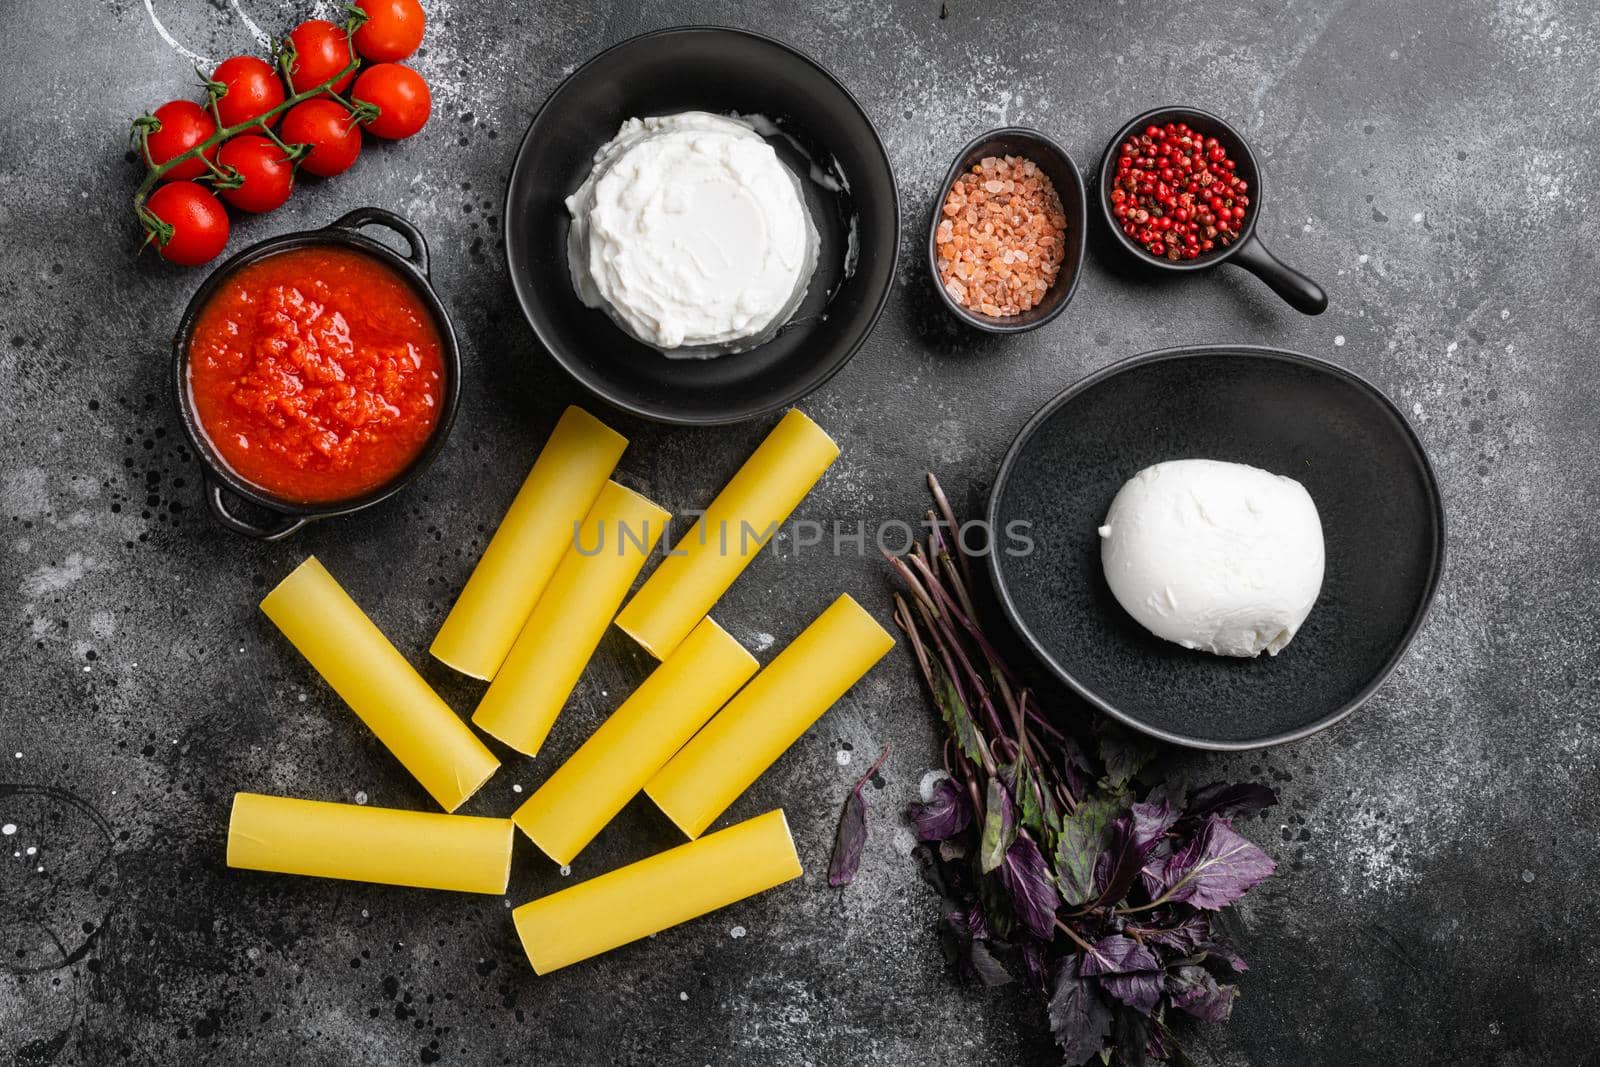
top-left (989, 346), bottom-right (1445, 749)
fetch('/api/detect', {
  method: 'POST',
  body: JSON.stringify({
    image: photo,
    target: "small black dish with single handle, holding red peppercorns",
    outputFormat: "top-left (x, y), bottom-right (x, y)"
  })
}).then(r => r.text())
top-left (1099, 107), bottom-right (1328, 315)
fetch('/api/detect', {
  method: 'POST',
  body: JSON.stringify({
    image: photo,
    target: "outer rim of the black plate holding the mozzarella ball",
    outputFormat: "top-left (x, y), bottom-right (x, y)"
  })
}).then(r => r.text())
top-left (984, 344), bottom-right (1446, 752)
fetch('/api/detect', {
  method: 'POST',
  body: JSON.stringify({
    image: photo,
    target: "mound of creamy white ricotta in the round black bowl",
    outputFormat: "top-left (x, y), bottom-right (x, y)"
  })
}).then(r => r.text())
top-left (566, 112), bottom-right (819, 357)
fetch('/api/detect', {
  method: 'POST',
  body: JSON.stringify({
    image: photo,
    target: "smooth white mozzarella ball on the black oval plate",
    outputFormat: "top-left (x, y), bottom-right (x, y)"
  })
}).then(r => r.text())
top-left (1099, 459), bottom-right (1323, 656)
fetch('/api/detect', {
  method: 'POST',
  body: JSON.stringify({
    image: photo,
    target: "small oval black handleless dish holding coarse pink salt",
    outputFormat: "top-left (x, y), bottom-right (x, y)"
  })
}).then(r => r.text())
top-left (928, 126), bottom-right (1088, 333)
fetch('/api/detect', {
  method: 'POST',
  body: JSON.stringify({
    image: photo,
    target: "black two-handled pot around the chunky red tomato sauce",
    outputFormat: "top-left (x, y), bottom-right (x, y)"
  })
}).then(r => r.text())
top-left (173, 208), bottom-right (461, 541)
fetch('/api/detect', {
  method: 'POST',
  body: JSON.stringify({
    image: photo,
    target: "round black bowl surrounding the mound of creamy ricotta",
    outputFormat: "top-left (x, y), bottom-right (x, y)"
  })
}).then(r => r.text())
top-left (506, 27), bottom-right (899, 424)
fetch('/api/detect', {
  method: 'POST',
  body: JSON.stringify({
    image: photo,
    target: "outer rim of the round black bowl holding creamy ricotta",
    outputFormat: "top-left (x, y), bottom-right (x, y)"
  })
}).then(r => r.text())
top-left (501, 22), bottom-right (901, 426)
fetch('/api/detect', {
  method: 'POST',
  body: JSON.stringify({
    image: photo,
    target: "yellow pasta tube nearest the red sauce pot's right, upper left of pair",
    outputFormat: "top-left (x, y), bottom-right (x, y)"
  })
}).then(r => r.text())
top-left (429, 408), bottom-right (627, 681)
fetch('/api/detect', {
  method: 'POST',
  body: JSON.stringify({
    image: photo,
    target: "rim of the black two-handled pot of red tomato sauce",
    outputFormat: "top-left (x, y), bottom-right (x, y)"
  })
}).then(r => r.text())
top-left (173, 208), bottom-right (461, 524)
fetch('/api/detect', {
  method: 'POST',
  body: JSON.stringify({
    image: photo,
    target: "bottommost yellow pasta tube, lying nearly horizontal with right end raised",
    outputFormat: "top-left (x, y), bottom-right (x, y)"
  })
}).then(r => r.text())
top-left (510, 811), bottom-right (802, 974)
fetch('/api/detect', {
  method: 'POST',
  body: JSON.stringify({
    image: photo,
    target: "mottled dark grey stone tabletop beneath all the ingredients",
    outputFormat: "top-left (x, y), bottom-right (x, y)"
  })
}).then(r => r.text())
top-left (0, 0), bottom-right (1600, 1064)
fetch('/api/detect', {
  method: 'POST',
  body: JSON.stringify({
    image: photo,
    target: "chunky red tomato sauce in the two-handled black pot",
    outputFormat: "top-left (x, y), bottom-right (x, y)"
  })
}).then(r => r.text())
top-left (189, 246), bottom-right (443, 504)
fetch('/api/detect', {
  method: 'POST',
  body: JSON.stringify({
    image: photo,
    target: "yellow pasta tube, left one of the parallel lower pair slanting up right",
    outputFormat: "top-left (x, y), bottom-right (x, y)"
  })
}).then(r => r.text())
top-left (512, 616), bottom-right (755, 864)
